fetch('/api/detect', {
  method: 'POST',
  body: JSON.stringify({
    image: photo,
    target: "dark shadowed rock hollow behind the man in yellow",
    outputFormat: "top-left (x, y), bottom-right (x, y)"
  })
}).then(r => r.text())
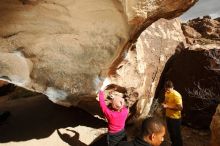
top-left (156, 49), bottom-right (220, 128)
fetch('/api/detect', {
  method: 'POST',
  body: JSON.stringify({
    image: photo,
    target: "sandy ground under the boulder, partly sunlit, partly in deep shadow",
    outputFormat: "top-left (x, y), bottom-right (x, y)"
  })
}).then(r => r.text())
top-left (0, 95), bottom-right (106, 146)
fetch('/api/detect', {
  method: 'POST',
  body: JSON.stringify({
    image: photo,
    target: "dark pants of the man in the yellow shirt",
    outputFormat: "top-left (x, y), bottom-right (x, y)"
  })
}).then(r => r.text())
top-left (166, 117), bottom-right (183, 146)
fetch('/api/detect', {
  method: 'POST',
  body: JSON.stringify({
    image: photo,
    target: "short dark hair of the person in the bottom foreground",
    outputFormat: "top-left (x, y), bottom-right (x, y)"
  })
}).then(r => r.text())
top-left (141, 117), bottom-right (165, 137)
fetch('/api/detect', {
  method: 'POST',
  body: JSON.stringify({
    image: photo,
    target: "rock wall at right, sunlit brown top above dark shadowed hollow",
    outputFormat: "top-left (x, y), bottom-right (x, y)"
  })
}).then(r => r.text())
top-left (166, 16), bottom-right (220, 128)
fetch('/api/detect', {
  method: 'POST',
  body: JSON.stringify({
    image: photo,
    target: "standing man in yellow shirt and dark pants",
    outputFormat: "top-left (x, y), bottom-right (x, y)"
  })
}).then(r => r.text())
top-left (163, 81), bottom-right (183, 146)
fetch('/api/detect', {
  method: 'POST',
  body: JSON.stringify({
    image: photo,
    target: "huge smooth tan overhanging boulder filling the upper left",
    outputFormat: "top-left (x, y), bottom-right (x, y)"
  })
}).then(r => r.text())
top-left (0, 0), bottom-right (196, 108)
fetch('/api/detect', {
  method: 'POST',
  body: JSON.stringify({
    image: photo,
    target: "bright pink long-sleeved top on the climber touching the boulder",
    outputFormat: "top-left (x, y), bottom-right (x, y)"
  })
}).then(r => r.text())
top-left (99, 91), bottom-right (128, 133)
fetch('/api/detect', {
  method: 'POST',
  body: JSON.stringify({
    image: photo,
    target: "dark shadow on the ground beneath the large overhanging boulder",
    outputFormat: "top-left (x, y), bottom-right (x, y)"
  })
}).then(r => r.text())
top-left (0, 95), bottom-right (106, 143)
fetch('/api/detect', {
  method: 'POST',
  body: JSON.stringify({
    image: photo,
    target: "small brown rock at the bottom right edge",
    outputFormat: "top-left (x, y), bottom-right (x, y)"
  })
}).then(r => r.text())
top-left (210, 105), bottom-right (220, 146)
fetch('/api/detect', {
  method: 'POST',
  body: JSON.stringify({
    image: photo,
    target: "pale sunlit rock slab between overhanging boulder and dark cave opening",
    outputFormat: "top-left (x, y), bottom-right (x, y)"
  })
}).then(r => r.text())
top-left (108, 19), bottom-right (185, 121)
